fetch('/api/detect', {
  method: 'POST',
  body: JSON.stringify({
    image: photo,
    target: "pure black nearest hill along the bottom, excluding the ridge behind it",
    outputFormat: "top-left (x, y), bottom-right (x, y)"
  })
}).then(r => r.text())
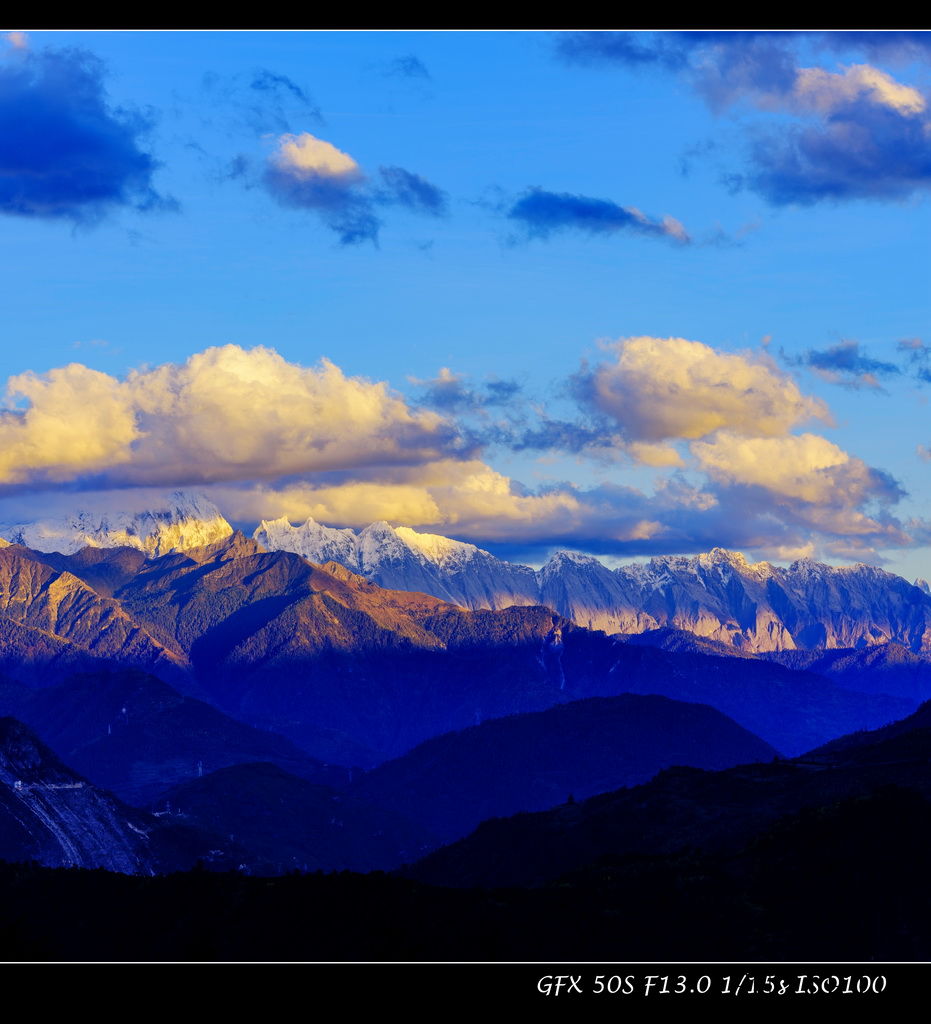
top-left (0, 786), bottom-right (931, 973)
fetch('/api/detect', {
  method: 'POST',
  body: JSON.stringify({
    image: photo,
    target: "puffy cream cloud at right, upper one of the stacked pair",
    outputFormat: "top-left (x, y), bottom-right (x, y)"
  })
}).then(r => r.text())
top-left (575, 337), bottom-right (831, 443)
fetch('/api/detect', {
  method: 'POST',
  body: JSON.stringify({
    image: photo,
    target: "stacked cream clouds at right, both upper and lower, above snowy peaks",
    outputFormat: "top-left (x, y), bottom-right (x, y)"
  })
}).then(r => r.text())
top-left (544, 337), bottom-right (914, 559)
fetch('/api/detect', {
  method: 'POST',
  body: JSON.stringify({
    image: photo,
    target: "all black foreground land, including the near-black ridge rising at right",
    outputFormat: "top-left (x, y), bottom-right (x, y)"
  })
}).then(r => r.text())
top-left (0, 696), bottom-right (931, 964)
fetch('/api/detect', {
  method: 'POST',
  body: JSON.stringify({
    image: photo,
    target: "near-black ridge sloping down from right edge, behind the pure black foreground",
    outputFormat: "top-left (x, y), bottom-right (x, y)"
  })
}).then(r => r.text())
top-left (411, 708), bottom-right (931, 887)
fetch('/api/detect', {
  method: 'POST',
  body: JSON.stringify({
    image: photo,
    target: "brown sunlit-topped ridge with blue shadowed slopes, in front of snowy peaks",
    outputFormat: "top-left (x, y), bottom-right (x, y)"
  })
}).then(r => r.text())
top-left (0, 534), bottom-right (915, 767)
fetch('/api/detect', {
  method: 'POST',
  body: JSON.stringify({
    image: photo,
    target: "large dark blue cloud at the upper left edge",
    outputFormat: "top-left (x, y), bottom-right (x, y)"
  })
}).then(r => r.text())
top-left (0, 49), bottom-right (177, 223)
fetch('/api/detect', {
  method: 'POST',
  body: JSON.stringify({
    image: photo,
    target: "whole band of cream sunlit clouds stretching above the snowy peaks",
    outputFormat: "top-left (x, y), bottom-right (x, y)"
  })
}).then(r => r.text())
top-left (0, 338), bottom-right (913, 559)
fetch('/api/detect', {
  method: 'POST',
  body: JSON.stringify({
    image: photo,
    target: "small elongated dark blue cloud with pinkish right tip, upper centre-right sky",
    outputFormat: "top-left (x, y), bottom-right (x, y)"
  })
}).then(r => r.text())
top-left (505, 187), bottom-right (690, 243)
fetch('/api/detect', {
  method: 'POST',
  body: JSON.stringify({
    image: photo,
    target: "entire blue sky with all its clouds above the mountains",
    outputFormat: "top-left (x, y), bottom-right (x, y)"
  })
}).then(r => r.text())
top-left (0, 27), bottom-right (931, 579)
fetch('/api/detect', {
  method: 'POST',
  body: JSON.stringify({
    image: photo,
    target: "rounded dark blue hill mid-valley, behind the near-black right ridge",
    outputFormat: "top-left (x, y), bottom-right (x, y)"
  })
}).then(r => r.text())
top-left (350, 693), bottom-right (777, 842)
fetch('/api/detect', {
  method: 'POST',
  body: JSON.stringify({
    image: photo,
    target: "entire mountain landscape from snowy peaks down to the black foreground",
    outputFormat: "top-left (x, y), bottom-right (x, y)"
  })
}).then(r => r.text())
top-left (0, 494), bottom-right (931, 958)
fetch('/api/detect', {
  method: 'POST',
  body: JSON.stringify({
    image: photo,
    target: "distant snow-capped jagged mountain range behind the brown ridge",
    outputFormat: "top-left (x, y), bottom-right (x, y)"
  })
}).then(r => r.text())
top-left (7, 492), bottom-right (931, 652)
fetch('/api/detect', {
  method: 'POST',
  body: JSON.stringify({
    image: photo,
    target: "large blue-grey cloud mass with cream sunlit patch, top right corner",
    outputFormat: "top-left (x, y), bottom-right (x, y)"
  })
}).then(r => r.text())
top-left (557, 32), bottom-right (931, 205)
